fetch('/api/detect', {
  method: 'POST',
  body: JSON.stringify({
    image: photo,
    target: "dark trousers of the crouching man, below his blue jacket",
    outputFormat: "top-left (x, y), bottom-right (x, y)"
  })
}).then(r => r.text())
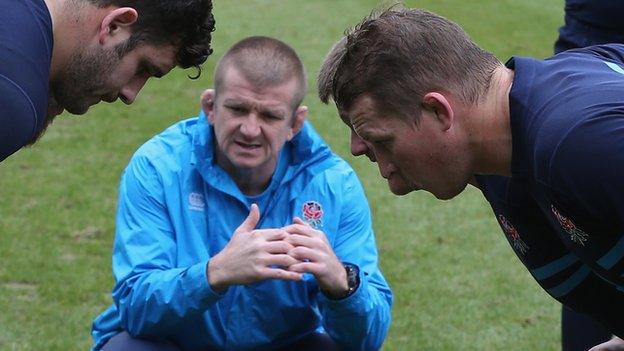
top-left (102, 332), bottom-right (340, 351)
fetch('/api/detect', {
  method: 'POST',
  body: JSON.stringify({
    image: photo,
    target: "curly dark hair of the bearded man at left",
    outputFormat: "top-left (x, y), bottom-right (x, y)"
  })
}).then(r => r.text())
top-left (84, 0), bottom-right (215, 77)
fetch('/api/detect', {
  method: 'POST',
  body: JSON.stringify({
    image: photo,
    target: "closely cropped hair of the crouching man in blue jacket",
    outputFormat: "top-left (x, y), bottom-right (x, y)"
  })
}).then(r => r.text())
top-left (214, 36), bottom-right (307, 110)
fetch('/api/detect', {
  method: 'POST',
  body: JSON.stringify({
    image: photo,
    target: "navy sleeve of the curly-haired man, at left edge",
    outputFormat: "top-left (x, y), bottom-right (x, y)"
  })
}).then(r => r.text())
top-left (0, 74), bottom-right (37, 161)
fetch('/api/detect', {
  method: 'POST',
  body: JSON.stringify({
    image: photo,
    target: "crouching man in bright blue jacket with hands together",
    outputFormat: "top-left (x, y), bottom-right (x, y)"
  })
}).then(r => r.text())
top-left (92, 37), bottom-right (392, 351)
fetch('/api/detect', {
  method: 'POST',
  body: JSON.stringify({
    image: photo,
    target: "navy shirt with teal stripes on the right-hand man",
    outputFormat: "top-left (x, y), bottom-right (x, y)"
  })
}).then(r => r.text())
top-left (477, 45), bottom-right (624, 336)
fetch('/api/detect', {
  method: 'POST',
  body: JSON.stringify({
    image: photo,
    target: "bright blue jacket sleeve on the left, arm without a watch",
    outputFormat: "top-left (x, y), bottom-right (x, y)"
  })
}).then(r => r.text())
top-left (113, 156), bottom-right (222, 338)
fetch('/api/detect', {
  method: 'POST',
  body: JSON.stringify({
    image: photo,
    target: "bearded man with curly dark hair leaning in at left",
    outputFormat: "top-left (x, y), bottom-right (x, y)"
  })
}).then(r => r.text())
top-left (0, 0), bottom-right (214, 161)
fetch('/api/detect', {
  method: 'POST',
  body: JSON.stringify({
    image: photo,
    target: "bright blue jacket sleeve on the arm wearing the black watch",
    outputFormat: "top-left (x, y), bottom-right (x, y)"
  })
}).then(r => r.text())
top-left (319, 171), bottom-right (392, 350)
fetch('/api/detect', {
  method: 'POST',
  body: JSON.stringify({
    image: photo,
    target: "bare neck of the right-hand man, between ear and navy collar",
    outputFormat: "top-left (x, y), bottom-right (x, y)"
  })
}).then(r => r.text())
top-left (469, 65), bottom-right (514, 176)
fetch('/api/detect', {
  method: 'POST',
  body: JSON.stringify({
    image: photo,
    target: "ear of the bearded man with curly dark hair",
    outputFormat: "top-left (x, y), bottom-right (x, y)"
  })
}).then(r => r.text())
top-left (98, 7), bottom-right (139, 46)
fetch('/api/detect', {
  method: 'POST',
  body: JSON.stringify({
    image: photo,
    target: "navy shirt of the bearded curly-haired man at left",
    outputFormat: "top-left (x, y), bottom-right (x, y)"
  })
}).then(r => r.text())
top-left (0, 0), bottom-right (53, 161)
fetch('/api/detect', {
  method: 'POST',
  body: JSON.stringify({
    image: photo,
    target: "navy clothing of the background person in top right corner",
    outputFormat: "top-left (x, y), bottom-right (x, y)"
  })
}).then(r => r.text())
top-left (555, 0), bottom-right (624, 52)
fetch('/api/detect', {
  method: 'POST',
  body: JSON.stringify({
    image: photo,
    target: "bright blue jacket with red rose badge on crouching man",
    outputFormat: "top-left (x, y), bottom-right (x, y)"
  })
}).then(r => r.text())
top-left (92, 113), bottom-right (392, 350)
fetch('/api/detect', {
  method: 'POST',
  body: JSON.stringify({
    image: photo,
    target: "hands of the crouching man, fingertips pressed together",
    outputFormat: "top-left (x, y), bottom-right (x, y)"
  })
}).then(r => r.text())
top-left (206, 204), bottom-right (348, 298)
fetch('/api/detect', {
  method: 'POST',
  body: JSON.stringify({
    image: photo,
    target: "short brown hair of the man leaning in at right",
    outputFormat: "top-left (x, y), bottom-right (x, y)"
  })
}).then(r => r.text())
top-left (318, 6), bottom-right (501, 121)
